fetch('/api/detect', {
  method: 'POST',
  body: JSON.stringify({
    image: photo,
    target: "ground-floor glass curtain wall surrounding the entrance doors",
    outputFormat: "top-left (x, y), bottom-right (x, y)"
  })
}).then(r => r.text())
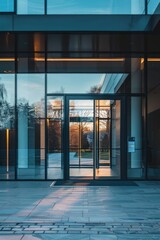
top-left (0, 33), bottom-right (153, 179)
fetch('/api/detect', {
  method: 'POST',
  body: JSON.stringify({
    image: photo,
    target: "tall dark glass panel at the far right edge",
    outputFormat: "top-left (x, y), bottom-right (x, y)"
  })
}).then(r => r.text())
top-left (147, 58), bottom-right (160, 179)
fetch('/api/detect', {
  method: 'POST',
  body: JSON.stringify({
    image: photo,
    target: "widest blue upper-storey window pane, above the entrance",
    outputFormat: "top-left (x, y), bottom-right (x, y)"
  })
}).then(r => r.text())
top-left (47, 0), bottom-right (145, 14)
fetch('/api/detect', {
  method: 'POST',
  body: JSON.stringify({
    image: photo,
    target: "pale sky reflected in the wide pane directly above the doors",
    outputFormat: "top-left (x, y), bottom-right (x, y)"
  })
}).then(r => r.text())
top-left (47, 74), bottom-right (103, 93)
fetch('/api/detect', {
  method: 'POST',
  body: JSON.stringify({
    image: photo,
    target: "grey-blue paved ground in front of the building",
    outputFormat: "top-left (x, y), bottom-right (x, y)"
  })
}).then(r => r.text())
top-left (0, 181), bottom-right (160, 240)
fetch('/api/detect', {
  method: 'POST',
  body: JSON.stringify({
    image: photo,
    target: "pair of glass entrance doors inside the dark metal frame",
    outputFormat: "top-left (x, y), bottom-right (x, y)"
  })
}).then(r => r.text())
top-left (68, 98), bottom-right (121, 179)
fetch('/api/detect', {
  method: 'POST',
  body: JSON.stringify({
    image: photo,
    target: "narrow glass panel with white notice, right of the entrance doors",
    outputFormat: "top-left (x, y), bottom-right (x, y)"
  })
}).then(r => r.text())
top-left (126, 97), bottom-right (145, 178)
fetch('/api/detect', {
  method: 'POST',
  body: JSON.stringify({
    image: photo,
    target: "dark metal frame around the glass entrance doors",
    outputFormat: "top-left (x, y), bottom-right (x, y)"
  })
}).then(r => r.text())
top-left (62, 94), bottom-right (127, 180)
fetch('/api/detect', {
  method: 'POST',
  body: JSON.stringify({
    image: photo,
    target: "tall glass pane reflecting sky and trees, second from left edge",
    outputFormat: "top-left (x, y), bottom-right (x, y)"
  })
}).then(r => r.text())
top-left (17, 74), bottom-right (45, 179)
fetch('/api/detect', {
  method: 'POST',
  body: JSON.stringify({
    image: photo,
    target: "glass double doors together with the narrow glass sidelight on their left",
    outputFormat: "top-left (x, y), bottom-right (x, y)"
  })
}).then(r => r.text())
top-left (47, 95), bottom-right (122, 179)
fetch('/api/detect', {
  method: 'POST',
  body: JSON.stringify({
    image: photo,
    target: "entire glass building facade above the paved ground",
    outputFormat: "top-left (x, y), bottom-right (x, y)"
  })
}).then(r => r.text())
top-left (0, 0), bottom-right (160, 180)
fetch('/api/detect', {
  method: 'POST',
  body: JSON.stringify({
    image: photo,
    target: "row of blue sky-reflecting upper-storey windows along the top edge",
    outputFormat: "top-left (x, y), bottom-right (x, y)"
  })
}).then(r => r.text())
top-left (0, 0), bottom-right (160, 14)
